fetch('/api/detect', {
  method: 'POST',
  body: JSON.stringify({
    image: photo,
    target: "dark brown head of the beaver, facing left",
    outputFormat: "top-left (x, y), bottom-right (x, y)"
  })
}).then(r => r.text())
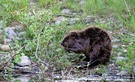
top-left (61, 32), bottom-right (89, 53)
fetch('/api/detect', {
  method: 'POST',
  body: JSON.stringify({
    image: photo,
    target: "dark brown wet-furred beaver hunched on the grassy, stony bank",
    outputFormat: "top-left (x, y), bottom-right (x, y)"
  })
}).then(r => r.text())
top-left (61, 27), bottom-right (112, 67)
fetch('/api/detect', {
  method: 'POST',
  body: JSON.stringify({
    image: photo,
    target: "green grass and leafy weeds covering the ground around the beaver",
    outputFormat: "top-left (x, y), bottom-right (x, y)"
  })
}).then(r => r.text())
top-left (0, 0), bottom-right (135, 80)
